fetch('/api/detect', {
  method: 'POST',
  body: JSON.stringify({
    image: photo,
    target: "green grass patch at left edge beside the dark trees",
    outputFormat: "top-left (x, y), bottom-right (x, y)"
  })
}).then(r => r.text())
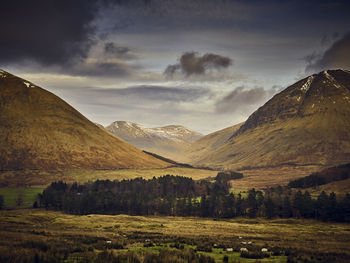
top-left (0, 187), bottom-right (44, 208)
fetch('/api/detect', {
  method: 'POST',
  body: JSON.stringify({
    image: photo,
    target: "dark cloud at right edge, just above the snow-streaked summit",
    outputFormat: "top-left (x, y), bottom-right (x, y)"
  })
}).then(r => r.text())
top-left (306, 33), bottom-right (350, 72)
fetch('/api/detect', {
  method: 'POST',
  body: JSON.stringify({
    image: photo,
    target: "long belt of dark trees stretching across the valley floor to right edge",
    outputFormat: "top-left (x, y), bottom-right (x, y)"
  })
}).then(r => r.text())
top-left (36, 175), bottom-right (350, 222)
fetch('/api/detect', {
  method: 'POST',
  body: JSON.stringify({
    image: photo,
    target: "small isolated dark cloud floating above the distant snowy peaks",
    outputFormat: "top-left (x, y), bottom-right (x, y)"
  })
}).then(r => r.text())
top-left (164, 52), bottom-right (232, 76)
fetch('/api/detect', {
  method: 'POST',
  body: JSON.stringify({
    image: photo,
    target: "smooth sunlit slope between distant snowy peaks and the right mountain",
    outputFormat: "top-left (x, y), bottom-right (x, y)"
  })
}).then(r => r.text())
top-left (179, 123), bottom-right (243, 163)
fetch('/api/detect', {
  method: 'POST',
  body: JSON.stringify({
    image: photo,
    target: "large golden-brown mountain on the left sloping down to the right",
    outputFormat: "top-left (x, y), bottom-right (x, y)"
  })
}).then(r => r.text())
top-left (0, 71), bottom-right (169, 170)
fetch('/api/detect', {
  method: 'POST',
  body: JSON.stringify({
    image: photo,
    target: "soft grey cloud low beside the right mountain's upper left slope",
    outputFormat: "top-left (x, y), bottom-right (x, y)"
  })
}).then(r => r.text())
top-left (215, 86), bottom-right (280, 113)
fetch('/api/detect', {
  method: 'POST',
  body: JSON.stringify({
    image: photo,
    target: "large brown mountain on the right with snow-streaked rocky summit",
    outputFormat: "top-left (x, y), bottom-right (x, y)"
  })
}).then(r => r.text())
top-left (192, 70), bottom-right (350, 169)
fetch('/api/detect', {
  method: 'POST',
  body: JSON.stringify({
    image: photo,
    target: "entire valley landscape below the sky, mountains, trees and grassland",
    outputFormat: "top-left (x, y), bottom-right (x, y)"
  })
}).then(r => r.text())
top-left (0, 70), bottom-right (350, 263)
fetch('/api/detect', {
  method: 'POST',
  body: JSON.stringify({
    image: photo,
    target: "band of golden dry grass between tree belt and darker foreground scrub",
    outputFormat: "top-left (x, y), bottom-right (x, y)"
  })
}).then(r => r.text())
top-left (0, 210), bottom-right (350, 257)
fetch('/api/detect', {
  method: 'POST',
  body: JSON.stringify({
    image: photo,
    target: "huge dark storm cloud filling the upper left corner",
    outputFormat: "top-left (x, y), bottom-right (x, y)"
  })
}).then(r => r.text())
top-left (0, 0), bottom-right (102, 65)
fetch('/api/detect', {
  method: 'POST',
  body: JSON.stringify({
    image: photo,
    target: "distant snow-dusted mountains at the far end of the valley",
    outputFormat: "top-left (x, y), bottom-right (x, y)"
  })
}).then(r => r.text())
top-left (106, 121), bottom-right (203, 160)
